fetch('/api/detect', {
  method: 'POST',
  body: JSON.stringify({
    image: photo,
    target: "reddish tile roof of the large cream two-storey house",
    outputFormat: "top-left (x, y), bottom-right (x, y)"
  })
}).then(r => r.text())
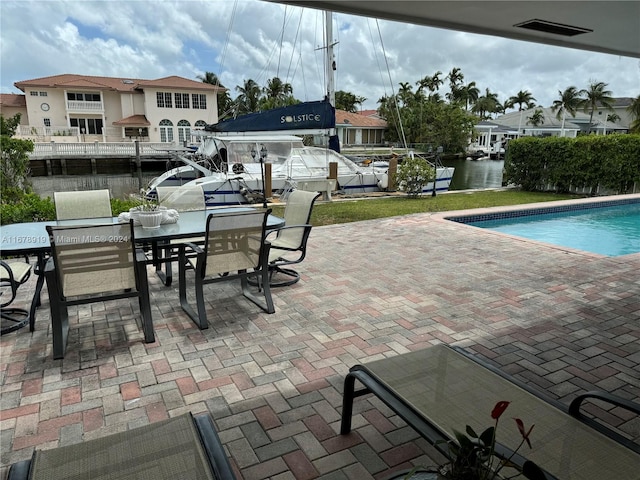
top-left (14, 73), bottom-right (226, 92)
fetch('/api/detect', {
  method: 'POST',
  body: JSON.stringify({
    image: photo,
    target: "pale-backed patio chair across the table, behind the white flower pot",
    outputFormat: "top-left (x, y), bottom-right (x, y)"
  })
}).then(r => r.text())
top-left (153, 185), bottom-right (206, 287)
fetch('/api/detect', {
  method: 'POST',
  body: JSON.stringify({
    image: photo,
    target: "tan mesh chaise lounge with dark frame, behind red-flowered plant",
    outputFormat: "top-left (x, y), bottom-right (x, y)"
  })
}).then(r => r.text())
top-left (341, 345), bottom-right (640, 480)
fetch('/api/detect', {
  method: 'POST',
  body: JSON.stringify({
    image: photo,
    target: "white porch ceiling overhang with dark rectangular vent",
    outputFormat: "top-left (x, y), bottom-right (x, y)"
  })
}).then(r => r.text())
top-left (269, 0), bottom-right (640, 58)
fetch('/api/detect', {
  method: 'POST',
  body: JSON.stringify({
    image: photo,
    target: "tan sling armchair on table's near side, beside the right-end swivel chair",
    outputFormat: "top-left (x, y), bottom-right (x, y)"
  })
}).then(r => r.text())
top-left (178, 210), bottom-right (275, 330)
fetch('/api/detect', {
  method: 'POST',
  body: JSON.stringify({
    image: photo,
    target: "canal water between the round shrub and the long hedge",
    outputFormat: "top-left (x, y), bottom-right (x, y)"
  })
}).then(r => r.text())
top-left (442, 158), bottom-right (504, 190)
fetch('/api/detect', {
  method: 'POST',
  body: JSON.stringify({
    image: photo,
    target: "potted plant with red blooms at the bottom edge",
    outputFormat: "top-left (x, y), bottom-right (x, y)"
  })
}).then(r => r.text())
top-left (404, 401), bottom-right (546, 480)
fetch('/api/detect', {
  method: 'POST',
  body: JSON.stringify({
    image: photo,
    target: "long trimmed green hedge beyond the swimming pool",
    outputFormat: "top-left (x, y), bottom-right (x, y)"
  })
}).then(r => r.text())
top-left (505, 135), bottom-right (640, 193)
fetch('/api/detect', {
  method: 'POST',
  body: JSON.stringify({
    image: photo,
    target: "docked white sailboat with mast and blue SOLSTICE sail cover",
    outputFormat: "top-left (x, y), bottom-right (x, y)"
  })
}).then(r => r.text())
top-left (147, 12), bottom-right (454, 206)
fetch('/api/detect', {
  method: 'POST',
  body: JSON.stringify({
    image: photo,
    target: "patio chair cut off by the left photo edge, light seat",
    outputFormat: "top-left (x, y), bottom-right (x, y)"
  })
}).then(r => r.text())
top-left (0, 260), bottom-right (31, 335)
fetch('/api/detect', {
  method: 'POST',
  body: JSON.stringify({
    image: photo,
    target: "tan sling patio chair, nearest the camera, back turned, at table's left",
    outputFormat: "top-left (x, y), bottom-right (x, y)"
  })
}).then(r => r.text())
top-left (45, 221), bottom-right (154, 358)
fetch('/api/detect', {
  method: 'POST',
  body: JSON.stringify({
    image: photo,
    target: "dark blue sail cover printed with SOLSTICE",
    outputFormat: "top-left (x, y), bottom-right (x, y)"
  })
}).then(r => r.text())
top-left (204, 100), bottom-right (336, 132)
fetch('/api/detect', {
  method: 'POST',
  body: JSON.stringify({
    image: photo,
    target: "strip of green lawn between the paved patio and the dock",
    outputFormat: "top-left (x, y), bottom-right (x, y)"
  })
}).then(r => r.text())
top-left (273, 190), bottom-right (584, 227)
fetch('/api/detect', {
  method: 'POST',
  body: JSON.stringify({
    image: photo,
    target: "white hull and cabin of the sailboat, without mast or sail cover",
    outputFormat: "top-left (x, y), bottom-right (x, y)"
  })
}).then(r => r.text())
top-left (148, 133), bottom-right (454, 206)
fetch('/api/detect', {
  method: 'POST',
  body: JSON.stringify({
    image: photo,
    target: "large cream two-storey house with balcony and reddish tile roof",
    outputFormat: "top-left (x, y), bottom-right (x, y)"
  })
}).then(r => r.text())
top-left (8, 74), bottom-right (225, 145)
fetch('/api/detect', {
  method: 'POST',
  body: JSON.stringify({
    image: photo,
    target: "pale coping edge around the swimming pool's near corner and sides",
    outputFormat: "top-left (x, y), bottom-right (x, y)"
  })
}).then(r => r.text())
top-left (431, 193), bottom-right (640, 260)
